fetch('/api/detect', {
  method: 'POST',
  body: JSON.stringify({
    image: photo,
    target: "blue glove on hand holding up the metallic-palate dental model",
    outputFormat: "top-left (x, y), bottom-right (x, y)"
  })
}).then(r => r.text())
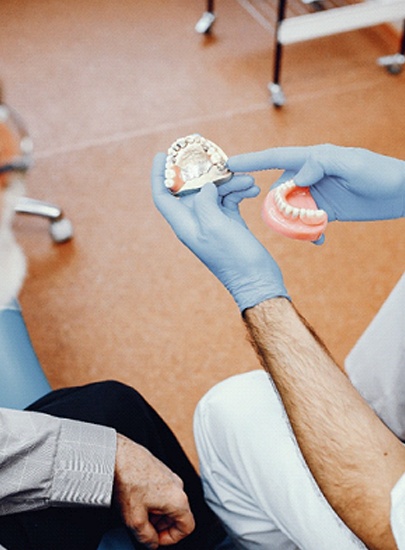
top-left (152, 153), bottom-right (288, 311)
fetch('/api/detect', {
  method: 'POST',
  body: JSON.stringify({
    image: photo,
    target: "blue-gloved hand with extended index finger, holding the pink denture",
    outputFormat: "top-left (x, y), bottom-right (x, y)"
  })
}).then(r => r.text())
top-left (228, 145), bottom-right (405, 221)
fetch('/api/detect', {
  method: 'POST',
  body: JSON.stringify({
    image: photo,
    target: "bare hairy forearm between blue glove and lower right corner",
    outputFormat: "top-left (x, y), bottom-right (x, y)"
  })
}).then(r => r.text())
top-left (244, 298), bottom-right (405, 550)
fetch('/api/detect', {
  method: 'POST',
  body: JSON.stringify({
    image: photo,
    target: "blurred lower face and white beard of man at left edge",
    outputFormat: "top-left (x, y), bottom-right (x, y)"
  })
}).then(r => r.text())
top-left (0, 175), bottom-right (26, 307)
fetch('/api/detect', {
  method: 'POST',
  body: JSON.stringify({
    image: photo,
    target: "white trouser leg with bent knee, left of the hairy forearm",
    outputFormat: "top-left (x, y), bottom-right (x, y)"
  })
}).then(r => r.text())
top-left (194, 371), bottom-right (365, 550)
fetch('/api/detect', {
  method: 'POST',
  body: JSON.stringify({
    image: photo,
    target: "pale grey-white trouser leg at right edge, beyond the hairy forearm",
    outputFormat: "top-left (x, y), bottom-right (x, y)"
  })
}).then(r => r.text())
top-left (345, 273), bottom-right (405, 440)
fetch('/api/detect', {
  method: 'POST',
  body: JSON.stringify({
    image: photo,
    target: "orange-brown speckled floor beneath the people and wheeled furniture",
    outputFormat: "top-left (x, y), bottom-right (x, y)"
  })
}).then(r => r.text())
top-left (0, 0), bottom-right (405, 461)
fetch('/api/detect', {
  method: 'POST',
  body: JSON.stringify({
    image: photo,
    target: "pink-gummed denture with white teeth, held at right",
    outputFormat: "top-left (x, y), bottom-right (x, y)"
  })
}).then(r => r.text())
top-left (262, 180), bottom-right (328, 241)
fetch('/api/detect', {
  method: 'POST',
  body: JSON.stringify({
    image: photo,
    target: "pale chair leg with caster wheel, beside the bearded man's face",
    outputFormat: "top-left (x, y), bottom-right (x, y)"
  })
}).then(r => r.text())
top-left (15, 197), bottom-right (73, 243)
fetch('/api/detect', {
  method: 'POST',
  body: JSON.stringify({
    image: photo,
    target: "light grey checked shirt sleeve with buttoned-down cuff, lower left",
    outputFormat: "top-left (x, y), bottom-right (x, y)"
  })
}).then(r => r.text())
top-left (0, 408), bottom-right (116, 515)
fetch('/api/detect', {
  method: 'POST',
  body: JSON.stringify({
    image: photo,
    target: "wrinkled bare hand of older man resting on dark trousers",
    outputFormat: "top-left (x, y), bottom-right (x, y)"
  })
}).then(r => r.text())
top-left (114, 435), bottom-right (195, 549)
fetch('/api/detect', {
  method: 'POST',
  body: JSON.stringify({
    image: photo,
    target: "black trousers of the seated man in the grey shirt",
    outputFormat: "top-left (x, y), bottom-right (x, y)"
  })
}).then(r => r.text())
top-left (0, 382), bottom-right (225, 550)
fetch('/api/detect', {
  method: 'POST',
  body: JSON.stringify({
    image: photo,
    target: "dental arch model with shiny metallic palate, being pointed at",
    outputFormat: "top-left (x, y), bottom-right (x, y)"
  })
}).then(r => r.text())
top-left (165, 134), bottom-right (232, 195)
